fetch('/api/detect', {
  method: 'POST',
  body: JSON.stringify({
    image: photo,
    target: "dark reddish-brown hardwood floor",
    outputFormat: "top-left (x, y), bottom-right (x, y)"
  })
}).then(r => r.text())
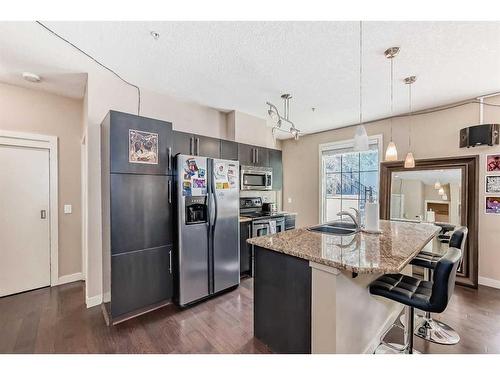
top-left (0, 279), bottom-right (500, 353)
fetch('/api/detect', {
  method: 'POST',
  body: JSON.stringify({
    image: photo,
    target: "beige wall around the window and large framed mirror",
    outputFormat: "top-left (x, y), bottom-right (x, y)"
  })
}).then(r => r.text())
top-left (282, 96), bottom-right (500, 282)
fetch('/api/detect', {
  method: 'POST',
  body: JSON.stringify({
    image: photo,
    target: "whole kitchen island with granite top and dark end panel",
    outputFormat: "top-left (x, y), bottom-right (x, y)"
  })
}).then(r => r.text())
top-left (248, 221), bottom-right (440, 353)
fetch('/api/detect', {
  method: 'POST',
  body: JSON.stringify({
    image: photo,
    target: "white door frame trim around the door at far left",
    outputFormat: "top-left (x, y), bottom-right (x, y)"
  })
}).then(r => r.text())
top-left (0, 129), bottom-right (59, 286)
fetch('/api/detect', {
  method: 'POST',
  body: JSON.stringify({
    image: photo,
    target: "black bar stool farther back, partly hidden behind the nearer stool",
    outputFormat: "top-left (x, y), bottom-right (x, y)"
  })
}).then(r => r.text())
top-left (410, 227), bottom-right (468, 345)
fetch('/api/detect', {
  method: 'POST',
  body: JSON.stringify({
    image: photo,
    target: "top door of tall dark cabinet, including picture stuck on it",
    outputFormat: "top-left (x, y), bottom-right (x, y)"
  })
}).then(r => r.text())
top-left (102, 111), bottom-right (173, 175)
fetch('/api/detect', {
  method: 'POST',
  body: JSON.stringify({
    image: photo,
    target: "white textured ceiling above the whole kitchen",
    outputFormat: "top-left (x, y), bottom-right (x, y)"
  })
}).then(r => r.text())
top-left (0, 22), bottom-right (500, 133)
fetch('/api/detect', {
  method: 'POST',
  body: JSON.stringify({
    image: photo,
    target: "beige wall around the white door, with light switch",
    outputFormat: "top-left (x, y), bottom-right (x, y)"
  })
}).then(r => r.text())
top-left (0, 83), bottom-right (83, 276)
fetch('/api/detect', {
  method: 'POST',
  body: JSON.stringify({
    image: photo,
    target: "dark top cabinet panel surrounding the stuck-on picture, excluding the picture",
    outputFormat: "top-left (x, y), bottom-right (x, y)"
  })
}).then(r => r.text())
top-left (107, 111), bottom-right (173, 174)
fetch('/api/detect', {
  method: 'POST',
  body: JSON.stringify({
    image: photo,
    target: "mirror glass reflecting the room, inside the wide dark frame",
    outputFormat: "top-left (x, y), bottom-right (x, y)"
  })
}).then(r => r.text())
top-left (390, 169), bottom-right (462, 225)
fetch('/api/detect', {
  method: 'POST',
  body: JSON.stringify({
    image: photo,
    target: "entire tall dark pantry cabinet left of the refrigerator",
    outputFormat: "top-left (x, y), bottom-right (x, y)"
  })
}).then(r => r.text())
top-left (101, 111), bottom-right (174, 324)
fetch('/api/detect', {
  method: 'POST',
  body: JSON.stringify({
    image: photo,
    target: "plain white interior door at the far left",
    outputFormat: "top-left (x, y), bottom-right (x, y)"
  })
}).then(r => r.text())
top-left (0, 145), bottom-right (50, 297)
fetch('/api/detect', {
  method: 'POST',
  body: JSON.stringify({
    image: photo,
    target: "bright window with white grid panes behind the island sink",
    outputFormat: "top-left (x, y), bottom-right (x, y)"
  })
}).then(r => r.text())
top-left (320, 136), bottom-right (382, 222)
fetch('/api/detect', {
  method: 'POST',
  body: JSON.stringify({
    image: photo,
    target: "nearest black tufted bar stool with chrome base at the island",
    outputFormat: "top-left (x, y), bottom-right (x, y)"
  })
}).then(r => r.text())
top-left (370, 248), bottom-right (462, 354)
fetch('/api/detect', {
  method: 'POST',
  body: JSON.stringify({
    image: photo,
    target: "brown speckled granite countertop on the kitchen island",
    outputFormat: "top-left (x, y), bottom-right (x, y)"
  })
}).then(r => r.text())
top-left (247, 220), bottom-right (441, 273)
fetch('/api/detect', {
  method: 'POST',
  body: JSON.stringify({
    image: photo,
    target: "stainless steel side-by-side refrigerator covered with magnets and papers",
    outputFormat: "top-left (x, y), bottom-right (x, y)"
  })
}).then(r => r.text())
top-left (175, 155), bottom-right (240, 306)
